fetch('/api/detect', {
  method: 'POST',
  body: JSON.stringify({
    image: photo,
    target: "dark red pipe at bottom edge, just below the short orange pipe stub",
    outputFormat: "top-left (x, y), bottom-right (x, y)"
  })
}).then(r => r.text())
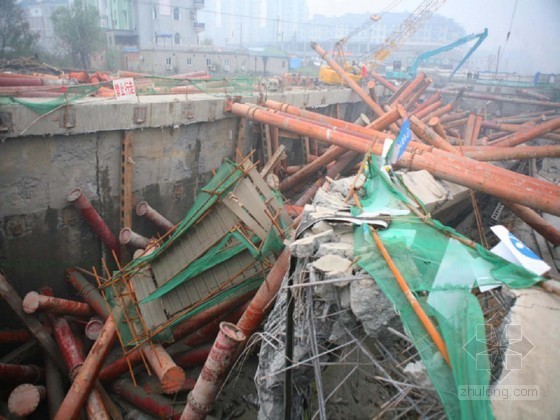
top-left (111, 379), bottom-right (183, 420)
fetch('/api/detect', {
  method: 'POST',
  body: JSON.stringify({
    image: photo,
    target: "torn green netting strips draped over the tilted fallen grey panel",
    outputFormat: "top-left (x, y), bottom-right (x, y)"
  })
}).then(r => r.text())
top-left (104, 160), bottom-right (285, 343)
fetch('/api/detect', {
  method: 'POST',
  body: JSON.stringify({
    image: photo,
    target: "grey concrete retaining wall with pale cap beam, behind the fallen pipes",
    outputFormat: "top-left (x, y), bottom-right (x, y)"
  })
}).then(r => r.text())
top-left (0, 90), bottom-right (363, 324)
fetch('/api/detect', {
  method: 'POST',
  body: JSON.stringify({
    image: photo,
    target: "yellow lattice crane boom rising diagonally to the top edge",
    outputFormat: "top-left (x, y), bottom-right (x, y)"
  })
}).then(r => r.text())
top-left (373, 0), bottom-right (446, 63)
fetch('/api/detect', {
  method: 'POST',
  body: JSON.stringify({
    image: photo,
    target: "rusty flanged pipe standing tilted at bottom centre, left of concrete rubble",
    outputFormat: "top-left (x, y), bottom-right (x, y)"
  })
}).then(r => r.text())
top-left (181, 322), bottom-right (246, 420)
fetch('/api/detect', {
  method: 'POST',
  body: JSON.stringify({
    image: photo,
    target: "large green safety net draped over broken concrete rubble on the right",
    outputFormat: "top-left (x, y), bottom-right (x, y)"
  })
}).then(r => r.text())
top-left (353, 158), bottom-right (543, 419)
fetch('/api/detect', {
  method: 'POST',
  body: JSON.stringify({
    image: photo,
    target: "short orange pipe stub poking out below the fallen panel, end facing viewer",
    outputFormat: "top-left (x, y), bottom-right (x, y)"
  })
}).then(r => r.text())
top-left (142, 344), bottom-right (185, 394)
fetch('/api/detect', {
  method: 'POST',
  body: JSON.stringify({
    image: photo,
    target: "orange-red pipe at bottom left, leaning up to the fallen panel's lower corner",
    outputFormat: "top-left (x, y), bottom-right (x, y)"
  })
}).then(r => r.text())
top-left (55, 313), bottom-right (121, 420)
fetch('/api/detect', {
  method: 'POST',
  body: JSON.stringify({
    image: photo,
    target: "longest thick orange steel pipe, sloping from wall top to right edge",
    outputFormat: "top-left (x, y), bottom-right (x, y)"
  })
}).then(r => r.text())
top-left (232, 103), bottom-right (560, 215)
